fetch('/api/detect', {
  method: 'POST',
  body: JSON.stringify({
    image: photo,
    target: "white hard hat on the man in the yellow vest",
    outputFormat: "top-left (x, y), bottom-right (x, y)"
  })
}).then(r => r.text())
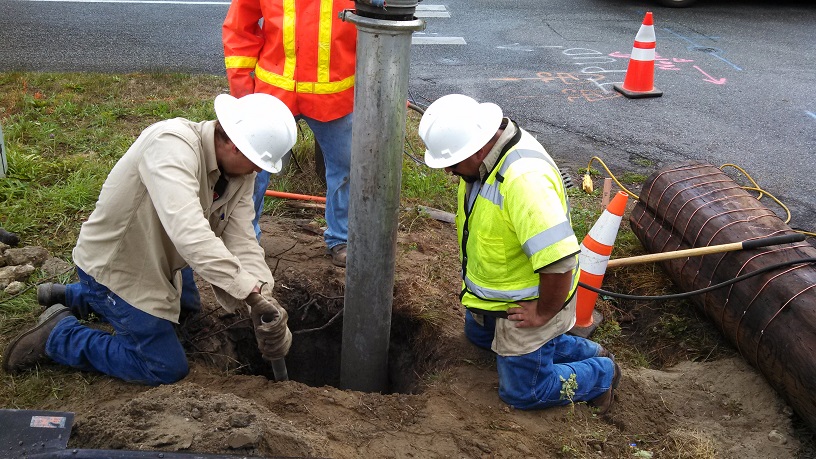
top-left (419, 94), bottom-right (502, 169)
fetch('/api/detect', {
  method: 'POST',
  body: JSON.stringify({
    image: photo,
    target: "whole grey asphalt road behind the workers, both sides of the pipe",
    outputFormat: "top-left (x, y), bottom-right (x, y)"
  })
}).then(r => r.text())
top-left (0, 0), bottom-right (816, 231)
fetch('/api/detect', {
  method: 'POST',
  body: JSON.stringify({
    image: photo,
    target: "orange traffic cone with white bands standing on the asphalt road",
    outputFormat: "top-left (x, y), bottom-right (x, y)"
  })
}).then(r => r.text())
top-left (613, 11), bottom-right (663, 99)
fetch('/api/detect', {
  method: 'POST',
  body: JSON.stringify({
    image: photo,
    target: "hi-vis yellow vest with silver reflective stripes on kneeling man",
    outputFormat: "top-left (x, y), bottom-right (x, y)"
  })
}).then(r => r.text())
top-left (456, 129), bottom-right (580, 313)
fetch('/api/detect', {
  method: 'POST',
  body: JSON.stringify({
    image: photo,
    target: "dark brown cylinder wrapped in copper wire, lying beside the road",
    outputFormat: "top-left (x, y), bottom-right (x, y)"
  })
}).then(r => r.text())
top-left (630, 162), bottom-right (816, 428)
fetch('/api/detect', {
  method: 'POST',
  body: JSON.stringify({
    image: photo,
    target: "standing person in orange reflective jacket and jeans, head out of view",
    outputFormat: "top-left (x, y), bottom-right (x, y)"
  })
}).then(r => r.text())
top-left (222, 0), bottom-right (357, 267)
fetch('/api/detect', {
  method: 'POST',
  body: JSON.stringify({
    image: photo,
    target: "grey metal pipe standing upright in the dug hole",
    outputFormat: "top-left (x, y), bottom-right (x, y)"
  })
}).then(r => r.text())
top-left (340, 0), bottom-right (425, 392)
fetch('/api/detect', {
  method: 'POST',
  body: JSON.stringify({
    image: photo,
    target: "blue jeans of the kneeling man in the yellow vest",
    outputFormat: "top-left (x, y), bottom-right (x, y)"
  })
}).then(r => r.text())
top-left (465, 311), bottom-right (615, 410)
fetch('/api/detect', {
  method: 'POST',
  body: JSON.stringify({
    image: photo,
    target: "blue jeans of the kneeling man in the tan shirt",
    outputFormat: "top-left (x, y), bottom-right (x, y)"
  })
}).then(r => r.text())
top-left (45, 268), bottom-right (189, 386)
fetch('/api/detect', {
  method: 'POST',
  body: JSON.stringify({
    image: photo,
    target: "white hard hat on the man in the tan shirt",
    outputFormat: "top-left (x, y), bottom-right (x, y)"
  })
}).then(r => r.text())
top-left (215, 93), bottom-right (297, 173)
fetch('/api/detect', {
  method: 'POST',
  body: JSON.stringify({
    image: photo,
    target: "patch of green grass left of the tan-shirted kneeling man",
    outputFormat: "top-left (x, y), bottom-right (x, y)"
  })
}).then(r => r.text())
top-left (0, 73), bottom-right (226, 255)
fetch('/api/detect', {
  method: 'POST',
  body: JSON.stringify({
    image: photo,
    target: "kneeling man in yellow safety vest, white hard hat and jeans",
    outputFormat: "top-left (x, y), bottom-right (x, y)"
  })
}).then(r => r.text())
top-left (419, 94), bottom-right (621, 413)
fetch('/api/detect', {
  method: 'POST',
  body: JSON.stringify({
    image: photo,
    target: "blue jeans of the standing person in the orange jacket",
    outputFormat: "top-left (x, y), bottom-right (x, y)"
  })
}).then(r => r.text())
top-left (252, 113), bottom-right (353, 248)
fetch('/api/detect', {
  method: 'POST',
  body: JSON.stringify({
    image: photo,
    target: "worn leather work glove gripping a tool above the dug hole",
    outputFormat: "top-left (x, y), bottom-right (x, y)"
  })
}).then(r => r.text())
top-left (245, 293), bottom-right (292, 361)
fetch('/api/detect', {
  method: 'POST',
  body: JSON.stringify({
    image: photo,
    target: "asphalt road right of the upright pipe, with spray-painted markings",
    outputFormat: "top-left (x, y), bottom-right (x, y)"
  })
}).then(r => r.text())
top-left (411, 0), bottom-right (816, 231)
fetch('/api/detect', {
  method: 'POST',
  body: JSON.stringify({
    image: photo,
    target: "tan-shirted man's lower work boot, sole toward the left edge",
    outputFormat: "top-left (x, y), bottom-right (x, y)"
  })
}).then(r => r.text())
top-left (3, 304), bottom-right (71, 373)
